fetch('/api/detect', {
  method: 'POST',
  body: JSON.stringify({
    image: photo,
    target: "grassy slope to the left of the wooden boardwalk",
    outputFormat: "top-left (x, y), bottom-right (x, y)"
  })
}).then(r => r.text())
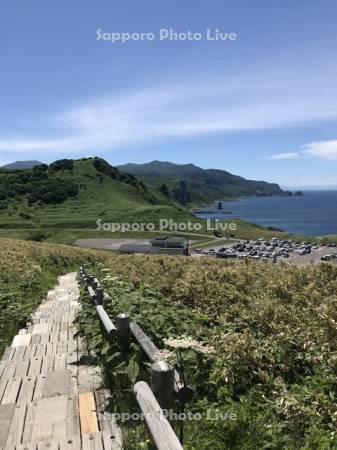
top-left (0, 239), bottom-right (105, 354)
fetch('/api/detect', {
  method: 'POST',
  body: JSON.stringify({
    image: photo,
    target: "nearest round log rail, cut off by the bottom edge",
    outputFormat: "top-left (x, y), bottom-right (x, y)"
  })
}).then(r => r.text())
top-left (134, 381), bottom-right (183, 450)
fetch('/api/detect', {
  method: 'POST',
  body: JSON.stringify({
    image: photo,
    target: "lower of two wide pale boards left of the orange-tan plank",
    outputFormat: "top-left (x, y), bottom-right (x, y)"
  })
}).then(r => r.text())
top-left (30, 396), bottom-right (68, 442)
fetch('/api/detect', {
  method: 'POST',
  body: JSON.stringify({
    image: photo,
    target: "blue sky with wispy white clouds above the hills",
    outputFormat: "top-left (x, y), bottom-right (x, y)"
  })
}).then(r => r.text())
top-left (0, 0), bottom-right (337, 189)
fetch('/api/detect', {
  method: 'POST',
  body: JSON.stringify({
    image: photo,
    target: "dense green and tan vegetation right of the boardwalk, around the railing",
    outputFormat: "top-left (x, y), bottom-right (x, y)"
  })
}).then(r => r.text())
top-left (78, 255), bottom-right (337, 450)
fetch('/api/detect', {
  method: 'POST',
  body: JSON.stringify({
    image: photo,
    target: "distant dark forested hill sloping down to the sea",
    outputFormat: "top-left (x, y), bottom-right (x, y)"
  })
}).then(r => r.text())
top-left (118, 161), bottom-right (289, 205)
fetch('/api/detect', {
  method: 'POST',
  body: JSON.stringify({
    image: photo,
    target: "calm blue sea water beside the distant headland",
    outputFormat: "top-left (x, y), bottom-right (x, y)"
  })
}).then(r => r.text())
top-left (196, 191), bottom-right (337, 236)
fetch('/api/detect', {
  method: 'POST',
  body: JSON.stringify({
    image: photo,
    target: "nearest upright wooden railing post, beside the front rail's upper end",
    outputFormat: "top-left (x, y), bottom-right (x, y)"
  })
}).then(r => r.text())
top-left (151, 360), bottom-right (174, 410)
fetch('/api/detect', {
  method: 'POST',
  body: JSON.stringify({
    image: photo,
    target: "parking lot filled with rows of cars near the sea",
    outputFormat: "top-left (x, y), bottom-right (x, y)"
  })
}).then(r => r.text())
top-left (192, 238), bottom-right (337, 265)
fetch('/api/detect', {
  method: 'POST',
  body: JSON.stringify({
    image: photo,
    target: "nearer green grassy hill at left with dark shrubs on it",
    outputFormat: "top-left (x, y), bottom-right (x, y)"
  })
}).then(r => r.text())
top-left (0, 158), bottom-right (191, 229)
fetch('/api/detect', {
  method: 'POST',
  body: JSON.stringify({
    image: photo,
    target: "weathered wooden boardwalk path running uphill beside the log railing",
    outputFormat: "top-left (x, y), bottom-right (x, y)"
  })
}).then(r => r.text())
top-left (0, 273), bottom-right (122, 450)
